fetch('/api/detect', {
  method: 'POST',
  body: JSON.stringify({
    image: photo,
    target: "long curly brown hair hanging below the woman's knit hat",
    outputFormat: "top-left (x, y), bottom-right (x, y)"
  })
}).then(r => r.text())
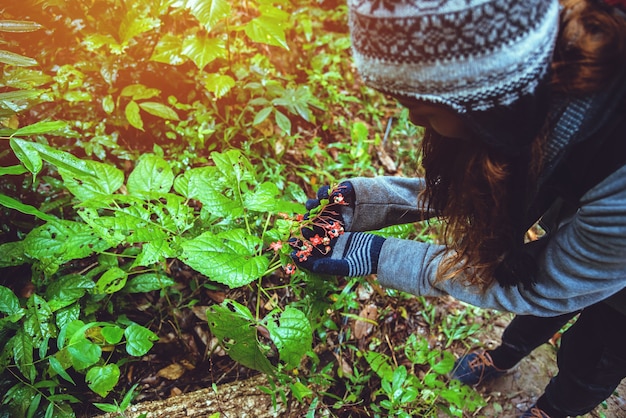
top-left (420, 0), bottom-right (626, 288)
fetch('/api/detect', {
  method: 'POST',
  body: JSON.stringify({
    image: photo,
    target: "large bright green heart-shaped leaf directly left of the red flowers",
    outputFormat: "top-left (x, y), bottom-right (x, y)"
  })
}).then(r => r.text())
top-left (180, 229), bottom-right (269, 288)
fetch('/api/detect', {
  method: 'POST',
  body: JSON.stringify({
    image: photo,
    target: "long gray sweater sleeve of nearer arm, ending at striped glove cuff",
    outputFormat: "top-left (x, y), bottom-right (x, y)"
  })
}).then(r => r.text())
top-left (378, 167), bottom-right (626, 316)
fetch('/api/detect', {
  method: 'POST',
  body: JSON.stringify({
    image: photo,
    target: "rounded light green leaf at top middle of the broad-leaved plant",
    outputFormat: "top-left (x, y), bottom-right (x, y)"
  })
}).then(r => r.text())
top-left (126, 154), bottom-right (174, 196)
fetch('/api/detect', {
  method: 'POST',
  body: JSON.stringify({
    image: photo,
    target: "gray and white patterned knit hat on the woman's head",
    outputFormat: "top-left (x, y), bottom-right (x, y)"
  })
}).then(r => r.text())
top-left (348, 0), bottom-right (559, 114)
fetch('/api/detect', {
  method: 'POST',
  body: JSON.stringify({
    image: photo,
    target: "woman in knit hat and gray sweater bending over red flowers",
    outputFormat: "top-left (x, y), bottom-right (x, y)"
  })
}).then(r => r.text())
top-left (293, 0), bottom-right (626, 418)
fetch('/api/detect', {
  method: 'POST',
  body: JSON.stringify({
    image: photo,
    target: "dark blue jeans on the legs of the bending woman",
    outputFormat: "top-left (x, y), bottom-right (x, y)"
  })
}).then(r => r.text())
top-left (490, 303), bottom-right (626, 418)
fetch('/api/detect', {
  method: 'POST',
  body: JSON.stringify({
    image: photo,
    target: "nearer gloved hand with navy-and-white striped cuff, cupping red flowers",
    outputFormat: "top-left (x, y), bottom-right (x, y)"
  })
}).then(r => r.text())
top-left (291, 229), bottom-right (385, 277)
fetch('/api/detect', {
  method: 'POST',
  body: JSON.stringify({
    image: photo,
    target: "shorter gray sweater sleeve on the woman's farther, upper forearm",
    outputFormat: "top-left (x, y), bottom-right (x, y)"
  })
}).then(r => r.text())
top-left (342, 176), bottom-right (429, 231)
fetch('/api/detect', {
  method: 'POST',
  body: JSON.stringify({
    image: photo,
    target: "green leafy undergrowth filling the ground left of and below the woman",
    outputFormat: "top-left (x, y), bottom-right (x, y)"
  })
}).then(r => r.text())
top-left (0, 0), bottom-right (486, 417)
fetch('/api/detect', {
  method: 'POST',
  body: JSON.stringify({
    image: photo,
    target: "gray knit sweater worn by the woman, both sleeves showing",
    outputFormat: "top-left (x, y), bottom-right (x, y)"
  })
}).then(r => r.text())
top-left (345, 166), bottom-right (626, 316)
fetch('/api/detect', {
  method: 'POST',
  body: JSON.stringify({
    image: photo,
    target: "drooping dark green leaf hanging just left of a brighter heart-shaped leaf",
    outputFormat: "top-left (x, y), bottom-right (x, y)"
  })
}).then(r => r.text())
top-left (207, 300), bottom-right (274, 375)
